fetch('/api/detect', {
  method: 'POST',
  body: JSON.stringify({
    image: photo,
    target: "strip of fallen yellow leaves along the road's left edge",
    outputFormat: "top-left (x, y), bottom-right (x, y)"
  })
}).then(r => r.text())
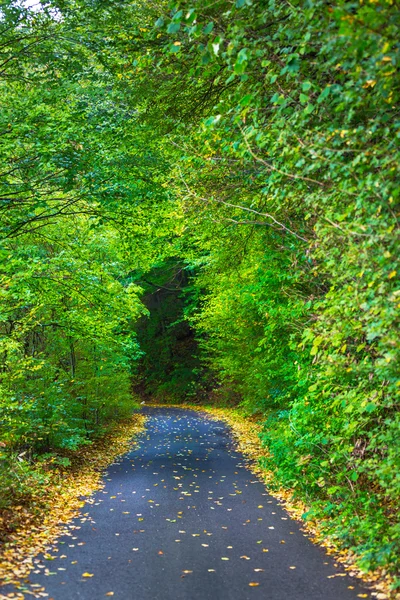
top-left (0, 413), bottom-right (146, 599)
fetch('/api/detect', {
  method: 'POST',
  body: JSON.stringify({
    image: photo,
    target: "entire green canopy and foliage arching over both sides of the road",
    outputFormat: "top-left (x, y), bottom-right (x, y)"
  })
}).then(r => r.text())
top-left (0, 0), bottom-right (400, 584)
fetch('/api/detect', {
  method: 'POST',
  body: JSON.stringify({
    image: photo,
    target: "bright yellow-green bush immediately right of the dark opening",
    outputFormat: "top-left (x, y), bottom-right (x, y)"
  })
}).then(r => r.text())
top-left (189, 230), bottom-right (306, 413)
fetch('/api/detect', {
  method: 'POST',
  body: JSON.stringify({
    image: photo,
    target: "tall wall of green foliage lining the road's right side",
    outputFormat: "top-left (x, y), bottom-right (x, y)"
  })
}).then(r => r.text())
top-left (129, 0), bottom-right (400, 568)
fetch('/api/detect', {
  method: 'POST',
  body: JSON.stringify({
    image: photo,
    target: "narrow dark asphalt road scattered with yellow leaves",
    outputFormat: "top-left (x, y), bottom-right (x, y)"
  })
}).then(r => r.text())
top-left (4, 408), bottom-right (370, 600)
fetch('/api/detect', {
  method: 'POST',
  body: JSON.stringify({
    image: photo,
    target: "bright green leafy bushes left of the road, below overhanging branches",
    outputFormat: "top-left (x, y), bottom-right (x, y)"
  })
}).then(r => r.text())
top-left (0, 219), bottom-right (142, 448)
